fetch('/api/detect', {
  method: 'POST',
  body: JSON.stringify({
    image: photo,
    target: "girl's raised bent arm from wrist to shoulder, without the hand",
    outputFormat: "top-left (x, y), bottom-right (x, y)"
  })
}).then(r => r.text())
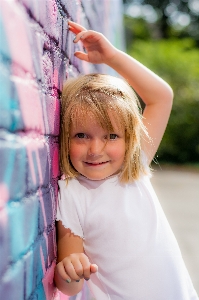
top-left (108, 50), bottom-right (173, 163)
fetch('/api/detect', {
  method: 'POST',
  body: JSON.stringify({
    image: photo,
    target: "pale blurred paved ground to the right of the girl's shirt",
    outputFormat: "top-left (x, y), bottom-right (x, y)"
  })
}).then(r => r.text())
top-left (151, 169), bottom-right (199, 295)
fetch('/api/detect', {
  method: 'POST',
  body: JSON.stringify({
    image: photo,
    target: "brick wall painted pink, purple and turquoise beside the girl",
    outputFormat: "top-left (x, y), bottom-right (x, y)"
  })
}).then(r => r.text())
top-left (0, 0), bottom-right (122, 300)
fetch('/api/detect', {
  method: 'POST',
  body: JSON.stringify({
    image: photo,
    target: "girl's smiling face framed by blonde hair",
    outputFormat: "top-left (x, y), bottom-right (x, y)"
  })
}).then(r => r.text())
top-left (69, 114), bottom-right (126, 180)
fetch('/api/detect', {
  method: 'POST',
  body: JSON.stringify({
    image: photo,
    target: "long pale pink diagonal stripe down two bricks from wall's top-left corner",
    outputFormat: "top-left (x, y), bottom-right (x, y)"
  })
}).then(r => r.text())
top-left (1, 1), bottom-right (44, 133)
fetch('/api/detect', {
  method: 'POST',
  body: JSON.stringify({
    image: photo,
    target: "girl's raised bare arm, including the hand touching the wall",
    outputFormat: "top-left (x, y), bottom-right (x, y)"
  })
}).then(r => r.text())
top-left (68, 21), bottom-right (173, 163)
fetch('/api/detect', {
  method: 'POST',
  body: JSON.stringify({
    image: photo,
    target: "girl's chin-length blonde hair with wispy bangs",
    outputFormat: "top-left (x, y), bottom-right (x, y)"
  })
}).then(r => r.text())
top-left (60, 74), bottom-right (148, 183)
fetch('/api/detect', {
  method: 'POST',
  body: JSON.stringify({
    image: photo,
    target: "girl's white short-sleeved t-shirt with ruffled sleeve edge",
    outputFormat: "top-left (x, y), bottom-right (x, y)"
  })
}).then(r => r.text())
top-left (57, 175), bottom-right (198, 300)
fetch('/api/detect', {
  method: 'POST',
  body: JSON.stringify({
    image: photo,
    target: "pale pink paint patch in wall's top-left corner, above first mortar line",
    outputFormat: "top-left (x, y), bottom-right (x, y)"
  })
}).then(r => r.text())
top-left (1, 1), bottom-right (34, 74)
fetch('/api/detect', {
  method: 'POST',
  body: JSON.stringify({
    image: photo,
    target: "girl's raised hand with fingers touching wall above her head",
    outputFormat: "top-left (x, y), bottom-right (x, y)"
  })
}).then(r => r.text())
top-left (68, 21), bottom-right (117, 64)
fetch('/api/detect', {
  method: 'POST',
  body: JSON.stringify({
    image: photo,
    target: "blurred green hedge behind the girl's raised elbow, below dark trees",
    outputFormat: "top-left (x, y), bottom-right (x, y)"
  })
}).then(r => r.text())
top-left (128, 39), bottom-right (199, 163)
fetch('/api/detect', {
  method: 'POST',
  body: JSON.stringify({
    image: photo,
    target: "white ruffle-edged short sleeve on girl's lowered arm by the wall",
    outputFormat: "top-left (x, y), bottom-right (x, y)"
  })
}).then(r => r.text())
top-left (56, 180), bottom-right (84, 238)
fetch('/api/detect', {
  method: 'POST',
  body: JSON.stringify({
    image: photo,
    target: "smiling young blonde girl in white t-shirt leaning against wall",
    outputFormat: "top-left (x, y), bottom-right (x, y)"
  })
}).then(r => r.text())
top-left (54, 22), bottom-right (198, 300)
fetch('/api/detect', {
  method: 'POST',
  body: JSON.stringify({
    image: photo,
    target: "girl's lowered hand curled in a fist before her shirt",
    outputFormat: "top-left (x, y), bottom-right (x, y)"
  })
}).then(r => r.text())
top-left (56, 253), bottom-right (98, 283)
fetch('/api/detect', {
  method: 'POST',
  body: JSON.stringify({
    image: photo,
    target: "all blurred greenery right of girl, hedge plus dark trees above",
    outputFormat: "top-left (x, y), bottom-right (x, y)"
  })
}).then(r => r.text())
top-left (123, 0), bottom-right (199, 165)
